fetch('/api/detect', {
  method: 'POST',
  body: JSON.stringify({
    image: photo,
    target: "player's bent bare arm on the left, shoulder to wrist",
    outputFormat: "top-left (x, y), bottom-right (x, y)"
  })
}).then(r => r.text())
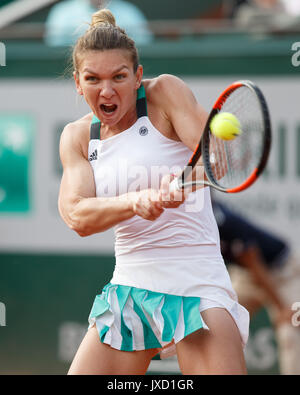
top-left (58, 125), bottom-right (135, 236)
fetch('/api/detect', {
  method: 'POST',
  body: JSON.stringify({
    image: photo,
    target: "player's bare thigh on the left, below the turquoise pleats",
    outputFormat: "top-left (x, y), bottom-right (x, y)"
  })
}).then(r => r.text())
top-left (68, 326), bottom-right (158, 375)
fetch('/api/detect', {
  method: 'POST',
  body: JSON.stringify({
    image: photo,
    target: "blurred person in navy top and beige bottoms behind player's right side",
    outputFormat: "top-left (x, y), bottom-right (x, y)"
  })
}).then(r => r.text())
top-left (213, 200), bottom-right (300, 375)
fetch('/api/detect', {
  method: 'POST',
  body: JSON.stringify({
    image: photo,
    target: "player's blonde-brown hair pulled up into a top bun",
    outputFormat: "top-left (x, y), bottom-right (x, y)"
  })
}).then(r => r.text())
top-left (73, 9), bottom-right (139, 72)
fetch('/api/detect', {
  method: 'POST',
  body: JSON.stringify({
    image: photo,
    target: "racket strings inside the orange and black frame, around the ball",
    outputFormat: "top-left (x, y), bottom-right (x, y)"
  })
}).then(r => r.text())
top-left (209, 86), bottom-right (264, 188)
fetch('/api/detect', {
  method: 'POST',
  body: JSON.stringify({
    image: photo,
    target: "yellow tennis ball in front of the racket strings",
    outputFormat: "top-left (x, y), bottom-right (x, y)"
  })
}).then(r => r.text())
top-left (210, 112), bottom-right (242, 140)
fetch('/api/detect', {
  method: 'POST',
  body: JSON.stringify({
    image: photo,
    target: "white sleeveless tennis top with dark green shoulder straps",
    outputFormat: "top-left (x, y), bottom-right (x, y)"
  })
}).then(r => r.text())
top-left (89, 87), bottom-right (235, 300)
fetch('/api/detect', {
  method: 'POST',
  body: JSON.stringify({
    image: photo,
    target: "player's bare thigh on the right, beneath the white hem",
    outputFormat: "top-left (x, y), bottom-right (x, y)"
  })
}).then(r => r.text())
top-left (176, 308), bottom-right (247, 374)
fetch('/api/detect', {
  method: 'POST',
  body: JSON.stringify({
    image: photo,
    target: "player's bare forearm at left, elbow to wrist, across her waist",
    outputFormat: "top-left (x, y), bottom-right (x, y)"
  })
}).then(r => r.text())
top-left (60, 194), bottom-right (135, 236)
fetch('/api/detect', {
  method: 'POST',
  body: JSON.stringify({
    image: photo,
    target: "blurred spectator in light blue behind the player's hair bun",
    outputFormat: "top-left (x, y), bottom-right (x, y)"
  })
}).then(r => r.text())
top-left (45, 0), bottom-right (153, 46)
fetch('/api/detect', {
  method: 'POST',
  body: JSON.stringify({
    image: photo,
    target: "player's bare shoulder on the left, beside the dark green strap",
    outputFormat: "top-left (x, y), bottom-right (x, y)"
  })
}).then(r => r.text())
top-left (60, 113), bottom-right (93, 160)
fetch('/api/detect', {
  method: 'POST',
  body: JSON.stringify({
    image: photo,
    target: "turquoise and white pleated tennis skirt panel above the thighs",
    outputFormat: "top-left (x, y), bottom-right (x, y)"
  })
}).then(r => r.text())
top-left (89, 283), bottom-right (210, 358)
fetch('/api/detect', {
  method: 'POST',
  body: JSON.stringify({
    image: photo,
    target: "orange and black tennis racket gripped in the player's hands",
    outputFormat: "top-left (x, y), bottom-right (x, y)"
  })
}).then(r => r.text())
top-left (170, 81), bottom-right (271, 193)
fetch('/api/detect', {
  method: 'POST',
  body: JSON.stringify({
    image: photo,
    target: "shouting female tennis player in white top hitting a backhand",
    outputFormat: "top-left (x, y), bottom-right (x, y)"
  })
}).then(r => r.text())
top-left (59, 10), bottom-right (249, 374)
